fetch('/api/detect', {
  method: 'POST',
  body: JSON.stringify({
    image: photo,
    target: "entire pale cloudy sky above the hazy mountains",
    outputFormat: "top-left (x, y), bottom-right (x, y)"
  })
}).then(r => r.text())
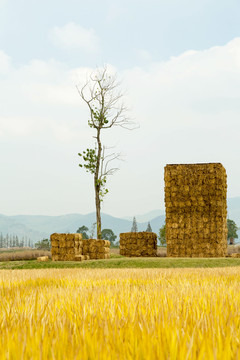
top-left (0, 0), bottom-right (240, 217)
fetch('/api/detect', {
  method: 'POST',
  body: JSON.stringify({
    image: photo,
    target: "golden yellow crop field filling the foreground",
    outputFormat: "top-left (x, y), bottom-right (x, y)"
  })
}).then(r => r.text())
top-left (0, 268), bottom-right (240, 360)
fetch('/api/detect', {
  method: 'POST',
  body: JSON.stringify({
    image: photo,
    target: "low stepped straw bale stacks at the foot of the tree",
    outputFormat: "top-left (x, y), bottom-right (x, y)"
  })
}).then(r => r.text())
top-left (51, 233), bottom-right (110, 261)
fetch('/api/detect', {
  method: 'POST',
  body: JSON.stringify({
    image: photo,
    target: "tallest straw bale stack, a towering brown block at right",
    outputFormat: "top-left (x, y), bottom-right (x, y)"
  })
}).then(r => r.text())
top-left (164, 163), bottom-right (227, 257)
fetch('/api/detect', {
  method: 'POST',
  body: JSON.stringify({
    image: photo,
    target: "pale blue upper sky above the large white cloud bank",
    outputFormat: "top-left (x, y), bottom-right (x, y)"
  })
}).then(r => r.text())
top-left (0, 0), bottom-right (240, 68)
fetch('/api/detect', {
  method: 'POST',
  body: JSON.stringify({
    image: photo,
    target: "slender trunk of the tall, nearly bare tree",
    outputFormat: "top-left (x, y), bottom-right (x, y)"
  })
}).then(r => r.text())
top-left (94, 129), bottom-right (102, 239)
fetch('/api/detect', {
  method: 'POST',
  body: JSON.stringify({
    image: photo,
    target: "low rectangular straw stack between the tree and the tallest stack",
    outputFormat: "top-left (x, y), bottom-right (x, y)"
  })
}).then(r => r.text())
top-left (120, 231), bottom-right (157, 256)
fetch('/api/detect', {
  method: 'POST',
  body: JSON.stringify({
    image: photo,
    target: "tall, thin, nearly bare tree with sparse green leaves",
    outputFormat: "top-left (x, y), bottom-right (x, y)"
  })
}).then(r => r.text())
top-left (77, 67), bottom-right (133, 239)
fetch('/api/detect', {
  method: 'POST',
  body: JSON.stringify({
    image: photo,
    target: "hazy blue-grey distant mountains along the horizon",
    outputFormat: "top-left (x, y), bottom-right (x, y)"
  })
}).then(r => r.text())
top-left (0, 197), bottom-right (240, 242)
